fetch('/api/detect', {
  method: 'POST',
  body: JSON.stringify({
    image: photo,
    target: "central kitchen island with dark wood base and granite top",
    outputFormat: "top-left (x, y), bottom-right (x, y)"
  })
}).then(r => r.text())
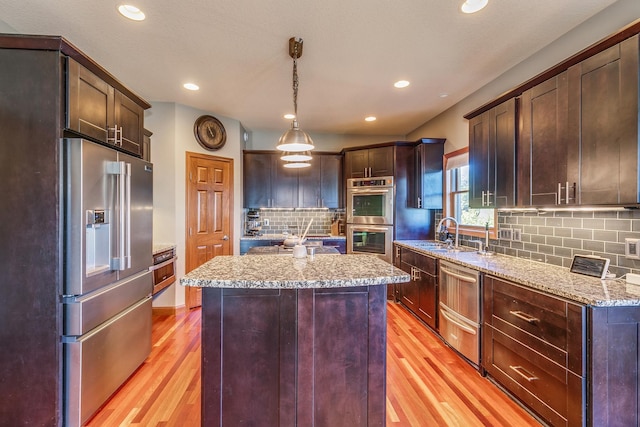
top-left (180, 255), bottom-right (410, 426)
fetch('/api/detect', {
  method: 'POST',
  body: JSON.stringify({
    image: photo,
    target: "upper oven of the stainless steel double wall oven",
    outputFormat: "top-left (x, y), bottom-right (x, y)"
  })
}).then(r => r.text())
top-left (346, 176), bottom-right (394, 225)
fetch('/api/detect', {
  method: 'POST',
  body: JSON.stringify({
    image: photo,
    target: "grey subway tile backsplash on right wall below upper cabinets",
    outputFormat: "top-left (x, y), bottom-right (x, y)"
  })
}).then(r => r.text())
top-left (448, 209), bottom-right (640, 277)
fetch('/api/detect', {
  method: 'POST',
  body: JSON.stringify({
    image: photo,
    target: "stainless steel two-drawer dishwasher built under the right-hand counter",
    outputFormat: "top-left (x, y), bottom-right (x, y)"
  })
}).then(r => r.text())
top-left (439, 261), bottom-right (481, 366)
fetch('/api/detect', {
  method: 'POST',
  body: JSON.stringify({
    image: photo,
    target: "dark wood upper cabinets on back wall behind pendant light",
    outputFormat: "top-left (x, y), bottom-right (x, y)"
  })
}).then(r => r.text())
top-left (243, 151), bottom-right (342, 208)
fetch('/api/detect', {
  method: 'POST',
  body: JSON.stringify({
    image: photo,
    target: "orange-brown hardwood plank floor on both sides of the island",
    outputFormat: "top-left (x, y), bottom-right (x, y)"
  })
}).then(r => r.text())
top-left (86, 303), bottom-right (540, 427)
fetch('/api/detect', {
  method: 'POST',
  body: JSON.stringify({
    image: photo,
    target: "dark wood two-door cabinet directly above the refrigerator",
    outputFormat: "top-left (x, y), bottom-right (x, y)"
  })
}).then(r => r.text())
top-left (66, 58), bottom-right (144, 156)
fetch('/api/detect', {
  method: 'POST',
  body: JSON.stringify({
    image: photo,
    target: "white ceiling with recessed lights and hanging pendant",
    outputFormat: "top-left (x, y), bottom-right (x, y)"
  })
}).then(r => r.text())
top-left (0, 0), bottom-right (615, 135)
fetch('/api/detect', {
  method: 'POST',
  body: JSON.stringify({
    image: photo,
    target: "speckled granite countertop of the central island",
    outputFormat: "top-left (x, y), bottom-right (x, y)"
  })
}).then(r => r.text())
top-left (180, 255), bottom-right (410, 289)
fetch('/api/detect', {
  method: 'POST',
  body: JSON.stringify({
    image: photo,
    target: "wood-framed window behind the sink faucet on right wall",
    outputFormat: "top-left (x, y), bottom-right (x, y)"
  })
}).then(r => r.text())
top-left (443, 147), bottom-right (497, 238)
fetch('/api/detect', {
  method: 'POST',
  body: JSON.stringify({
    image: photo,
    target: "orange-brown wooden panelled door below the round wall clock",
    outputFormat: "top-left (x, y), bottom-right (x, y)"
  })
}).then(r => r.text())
top-left (185, 152), bottom-right (233, 309)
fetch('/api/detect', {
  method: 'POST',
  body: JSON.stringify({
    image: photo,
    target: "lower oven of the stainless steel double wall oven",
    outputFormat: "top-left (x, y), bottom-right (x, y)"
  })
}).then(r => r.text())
top-left (347, 224), bottom-right (393, 263)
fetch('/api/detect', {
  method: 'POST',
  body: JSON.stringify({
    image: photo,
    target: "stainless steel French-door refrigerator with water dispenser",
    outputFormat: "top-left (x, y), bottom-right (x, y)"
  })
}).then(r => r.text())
top-left (61, 139), bottom-right (153, 426)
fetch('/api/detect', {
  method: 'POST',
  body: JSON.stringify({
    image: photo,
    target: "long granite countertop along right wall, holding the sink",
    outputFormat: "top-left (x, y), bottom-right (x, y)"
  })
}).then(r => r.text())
top-left (394, 240), bottom-right (640, 307)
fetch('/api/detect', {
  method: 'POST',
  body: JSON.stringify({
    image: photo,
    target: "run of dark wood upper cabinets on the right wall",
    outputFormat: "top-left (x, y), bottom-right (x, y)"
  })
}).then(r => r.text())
top-left (465, 23), bottom-right (640, 208)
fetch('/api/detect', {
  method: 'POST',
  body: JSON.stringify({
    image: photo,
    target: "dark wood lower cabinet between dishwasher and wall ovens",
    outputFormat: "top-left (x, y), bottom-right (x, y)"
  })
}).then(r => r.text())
top-left (395, 246), bottom-right (438, 330)
